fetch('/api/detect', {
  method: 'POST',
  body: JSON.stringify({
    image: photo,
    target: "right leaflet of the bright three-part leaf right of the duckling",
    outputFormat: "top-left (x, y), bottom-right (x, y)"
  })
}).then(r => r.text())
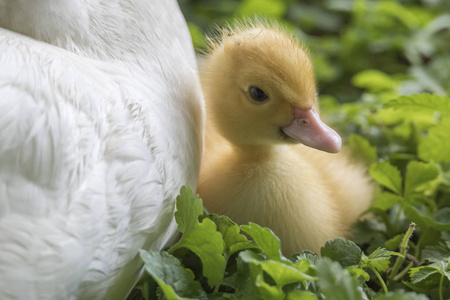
top-left (405, 161), bottom-right (439, 197)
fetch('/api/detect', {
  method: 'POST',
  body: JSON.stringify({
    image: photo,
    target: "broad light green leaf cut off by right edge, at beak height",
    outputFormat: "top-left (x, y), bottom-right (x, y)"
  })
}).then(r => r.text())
top-left (417, 118), bottom-right (450, 162)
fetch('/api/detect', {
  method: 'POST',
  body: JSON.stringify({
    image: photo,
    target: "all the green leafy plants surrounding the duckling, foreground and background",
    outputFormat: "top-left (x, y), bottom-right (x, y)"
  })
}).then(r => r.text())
top-left (128, 0), bottom-right (450, 300)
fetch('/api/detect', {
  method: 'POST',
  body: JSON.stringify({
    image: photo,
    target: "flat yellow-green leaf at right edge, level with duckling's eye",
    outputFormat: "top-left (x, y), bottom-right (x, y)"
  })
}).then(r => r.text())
top-left (383, 94), bottom-right (450, 115)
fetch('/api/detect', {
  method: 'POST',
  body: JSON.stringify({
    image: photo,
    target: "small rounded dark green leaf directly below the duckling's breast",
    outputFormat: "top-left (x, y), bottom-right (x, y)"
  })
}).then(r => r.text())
top-left (320, 238), bottom-right (362, 268)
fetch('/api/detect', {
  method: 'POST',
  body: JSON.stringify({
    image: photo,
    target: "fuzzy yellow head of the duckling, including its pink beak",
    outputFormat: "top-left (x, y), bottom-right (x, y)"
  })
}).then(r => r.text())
top-left (201, 23), bottom-right (342, 153)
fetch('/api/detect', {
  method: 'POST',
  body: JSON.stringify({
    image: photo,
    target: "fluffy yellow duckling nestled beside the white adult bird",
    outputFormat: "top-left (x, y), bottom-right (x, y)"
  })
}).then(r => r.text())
top-left (197, 21), bottom-right (373, 255)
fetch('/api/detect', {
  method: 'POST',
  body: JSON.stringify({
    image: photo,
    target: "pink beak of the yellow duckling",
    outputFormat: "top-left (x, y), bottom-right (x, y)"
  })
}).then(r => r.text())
top-left (281, 107), bottom-right (342, 153)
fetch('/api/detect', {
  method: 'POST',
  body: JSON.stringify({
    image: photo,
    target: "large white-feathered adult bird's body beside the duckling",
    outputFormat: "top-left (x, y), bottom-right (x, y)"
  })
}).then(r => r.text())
top-left (0, 0), bottom-right (203, 300)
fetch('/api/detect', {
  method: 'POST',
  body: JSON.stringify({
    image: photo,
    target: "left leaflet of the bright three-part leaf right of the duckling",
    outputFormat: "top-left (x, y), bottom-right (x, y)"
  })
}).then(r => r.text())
top-left (369, 162), bottom-right (402, 195)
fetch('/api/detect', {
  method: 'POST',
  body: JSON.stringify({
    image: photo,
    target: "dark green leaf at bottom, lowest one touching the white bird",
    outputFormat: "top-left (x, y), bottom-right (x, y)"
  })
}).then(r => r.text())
top-left (140, 250), bottom-right (201, 300)
